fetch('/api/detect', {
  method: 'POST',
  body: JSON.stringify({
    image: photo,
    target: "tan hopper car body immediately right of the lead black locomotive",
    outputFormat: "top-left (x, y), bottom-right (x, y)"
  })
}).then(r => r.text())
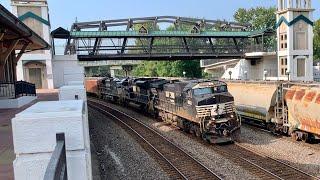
top-left (227, 82), bottom-right (279, 122)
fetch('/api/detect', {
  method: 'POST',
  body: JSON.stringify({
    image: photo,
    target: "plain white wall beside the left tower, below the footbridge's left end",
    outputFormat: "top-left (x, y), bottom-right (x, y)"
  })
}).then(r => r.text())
top-left (52, 55), bottom-right (84, 88)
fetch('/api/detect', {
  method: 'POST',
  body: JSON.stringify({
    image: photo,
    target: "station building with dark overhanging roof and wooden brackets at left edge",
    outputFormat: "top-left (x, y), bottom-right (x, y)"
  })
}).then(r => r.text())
top-left (0, 5), bottom-right (50, 109)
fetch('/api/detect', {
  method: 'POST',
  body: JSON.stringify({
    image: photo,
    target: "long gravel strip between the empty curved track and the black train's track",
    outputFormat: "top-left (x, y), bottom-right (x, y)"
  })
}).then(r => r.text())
top-left (97, 103), bottom-right (257, 180)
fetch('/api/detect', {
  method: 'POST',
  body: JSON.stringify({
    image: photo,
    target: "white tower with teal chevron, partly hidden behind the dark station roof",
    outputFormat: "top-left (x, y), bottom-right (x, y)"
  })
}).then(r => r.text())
top-left (11, 0), bottom-right (53, 89)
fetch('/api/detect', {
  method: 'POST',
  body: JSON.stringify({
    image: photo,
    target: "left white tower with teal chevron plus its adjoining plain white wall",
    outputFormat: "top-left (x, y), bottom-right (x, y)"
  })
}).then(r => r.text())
top-left (11, 0), bottom-right (84, 89)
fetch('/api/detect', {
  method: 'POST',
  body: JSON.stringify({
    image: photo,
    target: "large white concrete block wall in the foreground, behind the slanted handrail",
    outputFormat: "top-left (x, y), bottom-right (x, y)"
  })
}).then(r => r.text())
top-left (12, 100), bottom-right (92, 180)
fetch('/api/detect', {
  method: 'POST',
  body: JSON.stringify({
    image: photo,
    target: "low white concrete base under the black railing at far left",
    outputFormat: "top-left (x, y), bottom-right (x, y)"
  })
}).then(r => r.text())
top-left (0, 96), bottom-right (37, 109)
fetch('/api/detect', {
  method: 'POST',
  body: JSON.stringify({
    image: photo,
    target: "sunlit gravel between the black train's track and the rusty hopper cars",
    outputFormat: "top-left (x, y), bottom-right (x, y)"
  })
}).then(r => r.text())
top-left (240, 125), bottom-right (320, 179)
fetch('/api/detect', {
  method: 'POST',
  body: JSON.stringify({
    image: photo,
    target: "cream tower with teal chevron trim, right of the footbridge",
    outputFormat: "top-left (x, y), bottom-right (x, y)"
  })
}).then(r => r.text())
top-left (276, 0), bottom-right (314, 81)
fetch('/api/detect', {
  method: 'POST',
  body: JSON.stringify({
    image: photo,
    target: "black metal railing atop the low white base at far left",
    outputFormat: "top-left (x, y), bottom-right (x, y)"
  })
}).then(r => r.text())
top-left (0, 81), bottom-right (36, 99)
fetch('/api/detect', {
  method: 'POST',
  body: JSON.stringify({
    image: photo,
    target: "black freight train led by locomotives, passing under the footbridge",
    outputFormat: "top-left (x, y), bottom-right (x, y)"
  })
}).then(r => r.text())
top-left (86, 78), bottom-right (241, 143)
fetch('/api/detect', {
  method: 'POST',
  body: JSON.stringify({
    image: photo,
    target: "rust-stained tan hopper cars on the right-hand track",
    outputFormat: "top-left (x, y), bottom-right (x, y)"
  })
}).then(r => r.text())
top-left (225, 81), bottom-right (320, 142)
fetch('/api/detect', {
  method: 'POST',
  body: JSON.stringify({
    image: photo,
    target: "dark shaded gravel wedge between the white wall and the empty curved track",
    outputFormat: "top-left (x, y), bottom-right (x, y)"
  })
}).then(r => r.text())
top-left (89, 108), bottom-right (169, 180)
